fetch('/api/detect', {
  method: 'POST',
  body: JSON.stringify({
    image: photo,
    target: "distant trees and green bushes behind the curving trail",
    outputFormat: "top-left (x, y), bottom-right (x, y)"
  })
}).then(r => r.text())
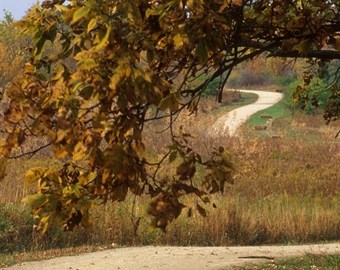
top-left (202, 54), bottom-right (339, 117)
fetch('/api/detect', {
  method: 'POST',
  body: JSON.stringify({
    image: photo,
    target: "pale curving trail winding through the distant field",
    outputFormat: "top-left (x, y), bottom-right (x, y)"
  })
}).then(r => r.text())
top-left (209, 89), bottom-right (283, 136)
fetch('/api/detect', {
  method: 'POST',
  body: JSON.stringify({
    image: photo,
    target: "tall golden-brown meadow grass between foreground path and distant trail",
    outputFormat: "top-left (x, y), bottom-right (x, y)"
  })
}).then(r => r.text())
top-left (0, 95), bottom-right (340, 255)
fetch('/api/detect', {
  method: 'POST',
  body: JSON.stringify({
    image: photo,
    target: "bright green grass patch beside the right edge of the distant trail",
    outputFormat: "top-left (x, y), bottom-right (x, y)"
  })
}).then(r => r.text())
top-left (248, 101), bottom-right (291, 126)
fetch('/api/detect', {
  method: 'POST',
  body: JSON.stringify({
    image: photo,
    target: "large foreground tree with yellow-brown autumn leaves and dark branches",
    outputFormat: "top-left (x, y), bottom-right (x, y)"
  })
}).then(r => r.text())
top-left (1, 0), bottom-right (340, 230)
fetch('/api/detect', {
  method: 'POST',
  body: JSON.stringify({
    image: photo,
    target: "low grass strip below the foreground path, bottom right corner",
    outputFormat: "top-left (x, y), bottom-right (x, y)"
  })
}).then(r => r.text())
top-left (239, 254), bottom-right (340, 270)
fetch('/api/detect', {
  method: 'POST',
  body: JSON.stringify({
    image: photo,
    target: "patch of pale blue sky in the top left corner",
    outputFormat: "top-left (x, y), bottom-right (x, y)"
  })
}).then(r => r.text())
top-left (0, 0), bottom-right (37, 20)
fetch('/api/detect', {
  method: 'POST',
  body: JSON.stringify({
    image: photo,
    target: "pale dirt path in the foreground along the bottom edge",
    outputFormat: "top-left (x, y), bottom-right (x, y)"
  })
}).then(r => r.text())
top-left (3, 243), bottom-right (340, 270)
